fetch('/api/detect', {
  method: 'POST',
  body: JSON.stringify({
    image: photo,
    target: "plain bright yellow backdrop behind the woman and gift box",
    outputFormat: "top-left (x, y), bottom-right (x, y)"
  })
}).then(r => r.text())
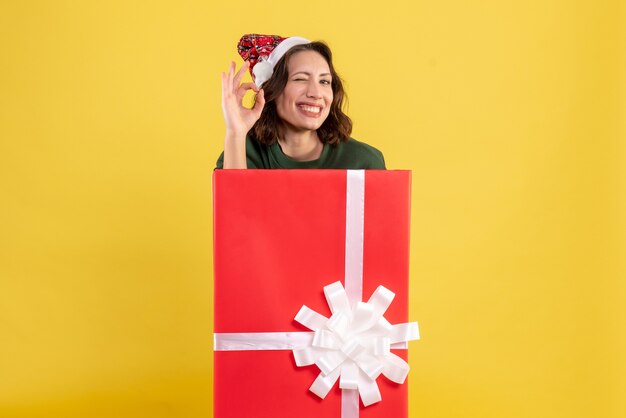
top-left (0, 0), bottom-right (626, 418)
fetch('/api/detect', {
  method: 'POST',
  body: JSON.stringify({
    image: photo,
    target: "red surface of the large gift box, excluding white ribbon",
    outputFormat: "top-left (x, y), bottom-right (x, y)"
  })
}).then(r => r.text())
top-left (213, 170), bottom-right (410, 418)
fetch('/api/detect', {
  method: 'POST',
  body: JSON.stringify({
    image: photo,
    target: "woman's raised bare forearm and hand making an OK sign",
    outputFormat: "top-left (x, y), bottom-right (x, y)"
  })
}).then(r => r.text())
top-left (222, 62), bottom-right (265, 168)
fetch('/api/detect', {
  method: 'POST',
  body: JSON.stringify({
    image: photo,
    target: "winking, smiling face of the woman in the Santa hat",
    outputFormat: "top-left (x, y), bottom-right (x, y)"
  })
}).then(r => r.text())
top-left (276, 51), bottom-right (333, 131)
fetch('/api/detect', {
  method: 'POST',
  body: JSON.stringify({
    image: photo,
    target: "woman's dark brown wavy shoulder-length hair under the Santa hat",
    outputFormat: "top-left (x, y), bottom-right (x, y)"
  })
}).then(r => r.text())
top-left (252, 41), bottom-right (352, 145)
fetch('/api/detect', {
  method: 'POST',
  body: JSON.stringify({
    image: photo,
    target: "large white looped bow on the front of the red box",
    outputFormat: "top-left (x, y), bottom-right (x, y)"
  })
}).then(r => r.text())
top-left (293, 282), bottom-right (419, 406)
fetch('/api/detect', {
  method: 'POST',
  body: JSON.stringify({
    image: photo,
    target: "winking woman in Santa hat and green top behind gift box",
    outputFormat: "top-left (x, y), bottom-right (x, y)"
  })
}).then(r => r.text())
top-left (217, 34), bottom-right (385, 169)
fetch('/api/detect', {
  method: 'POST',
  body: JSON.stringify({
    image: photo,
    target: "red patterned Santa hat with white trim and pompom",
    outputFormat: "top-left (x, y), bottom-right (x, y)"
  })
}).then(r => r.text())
top-left (237, 33), bottom-right (311, 88)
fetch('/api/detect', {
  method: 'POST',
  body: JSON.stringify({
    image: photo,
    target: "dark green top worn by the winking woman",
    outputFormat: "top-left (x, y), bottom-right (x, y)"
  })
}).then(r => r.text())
top-left (216, 135), bottom-right (385, 170)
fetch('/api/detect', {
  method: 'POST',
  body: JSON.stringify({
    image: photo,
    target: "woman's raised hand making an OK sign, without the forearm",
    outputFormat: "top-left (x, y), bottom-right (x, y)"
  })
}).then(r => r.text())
top-left (222, 61), bottom-right (265, 135)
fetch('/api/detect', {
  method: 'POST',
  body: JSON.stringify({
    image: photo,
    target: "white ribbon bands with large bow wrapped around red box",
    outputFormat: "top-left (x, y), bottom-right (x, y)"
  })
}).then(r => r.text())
top-left (214, 170), bottom-right (419, 418)
